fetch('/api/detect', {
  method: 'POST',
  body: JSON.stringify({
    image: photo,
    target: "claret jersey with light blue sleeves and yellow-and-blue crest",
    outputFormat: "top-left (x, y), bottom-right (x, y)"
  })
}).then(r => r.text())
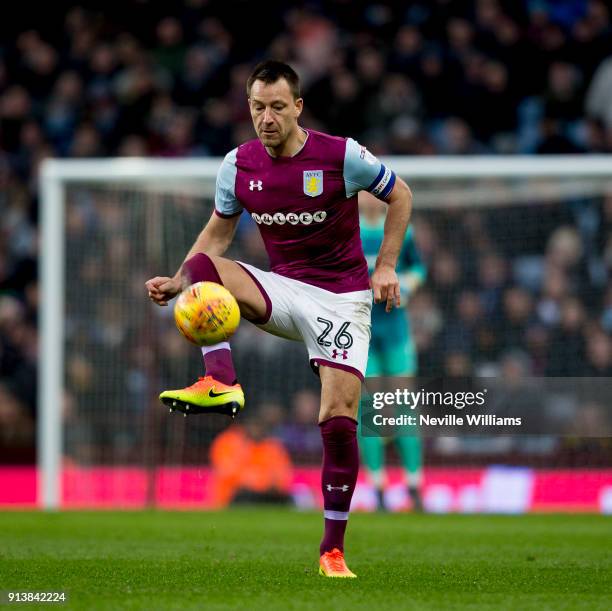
top-left (215, 130), bottom-right (395, 293)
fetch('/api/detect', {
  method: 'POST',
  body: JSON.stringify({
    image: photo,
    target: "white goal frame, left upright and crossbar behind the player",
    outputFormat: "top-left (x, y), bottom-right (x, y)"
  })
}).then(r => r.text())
top-left (37, 155), bottom-right (612, 509)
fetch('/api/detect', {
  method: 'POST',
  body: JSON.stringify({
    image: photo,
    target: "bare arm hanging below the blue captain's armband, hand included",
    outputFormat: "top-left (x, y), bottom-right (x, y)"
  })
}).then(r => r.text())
top-left (370, 177), bottom-right (412, 312)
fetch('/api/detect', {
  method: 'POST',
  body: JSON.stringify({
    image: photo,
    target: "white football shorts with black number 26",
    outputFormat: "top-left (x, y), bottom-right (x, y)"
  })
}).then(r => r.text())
top-left (237, 261), bottom-right (372, 381)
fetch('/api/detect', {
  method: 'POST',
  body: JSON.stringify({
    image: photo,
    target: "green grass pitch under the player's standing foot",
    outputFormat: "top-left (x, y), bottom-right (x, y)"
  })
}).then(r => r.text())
top-left (0, 508), bottom-right (612, 611)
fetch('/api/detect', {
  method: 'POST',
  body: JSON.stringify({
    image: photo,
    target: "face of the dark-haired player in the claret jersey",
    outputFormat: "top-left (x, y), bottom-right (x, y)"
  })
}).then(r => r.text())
top-left (249, 78), bottom-right (304, 148)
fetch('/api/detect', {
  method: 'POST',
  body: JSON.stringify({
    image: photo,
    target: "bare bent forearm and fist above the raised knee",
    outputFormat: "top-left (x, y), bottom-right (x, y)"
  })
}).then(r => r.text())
top-left (145, 212), bottom-right (239, 306)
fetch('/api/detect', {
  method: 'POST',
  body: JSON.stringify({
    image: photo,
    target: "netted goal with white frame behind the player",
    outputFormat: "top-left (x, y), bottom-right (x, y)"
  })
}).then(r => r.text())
top-left (38, 157), bottom-right (612, 511)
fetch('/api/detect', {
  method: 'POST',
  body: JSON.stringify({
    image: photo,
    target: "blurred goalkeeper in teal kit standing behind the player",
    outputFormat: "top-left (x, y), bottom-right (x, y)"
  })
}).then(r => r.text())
top-left (359, 191), bottom-right (425, 511)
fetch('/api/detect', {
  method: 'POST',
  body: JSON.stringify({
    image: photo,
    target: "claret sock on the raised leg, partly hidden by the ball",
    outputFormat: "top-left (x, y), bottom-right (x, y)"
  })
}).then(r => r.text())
top-left (182, 252), bottom-right (237, 384)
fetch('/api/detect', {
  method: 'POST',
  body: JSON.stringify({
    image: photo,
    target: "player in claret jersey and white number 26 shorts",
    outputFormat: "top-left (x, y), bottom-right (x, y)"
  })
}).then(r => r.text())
top-left (146, 61), bottom-right (412, 577)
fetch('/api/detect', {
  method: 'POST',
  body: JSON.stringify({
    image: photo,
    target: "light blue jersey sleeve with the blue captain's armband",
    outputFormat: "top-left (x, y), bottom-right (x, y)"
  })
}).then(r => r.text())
top-left (344, 138), bottom-right (395, 199)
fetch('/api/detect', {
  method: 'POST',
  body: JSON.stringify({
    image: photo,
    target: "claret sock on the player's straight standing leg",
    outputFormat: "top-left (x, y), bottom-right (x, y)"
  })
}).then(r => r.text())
top-left (319, 416), bottom-right (359, 554)
